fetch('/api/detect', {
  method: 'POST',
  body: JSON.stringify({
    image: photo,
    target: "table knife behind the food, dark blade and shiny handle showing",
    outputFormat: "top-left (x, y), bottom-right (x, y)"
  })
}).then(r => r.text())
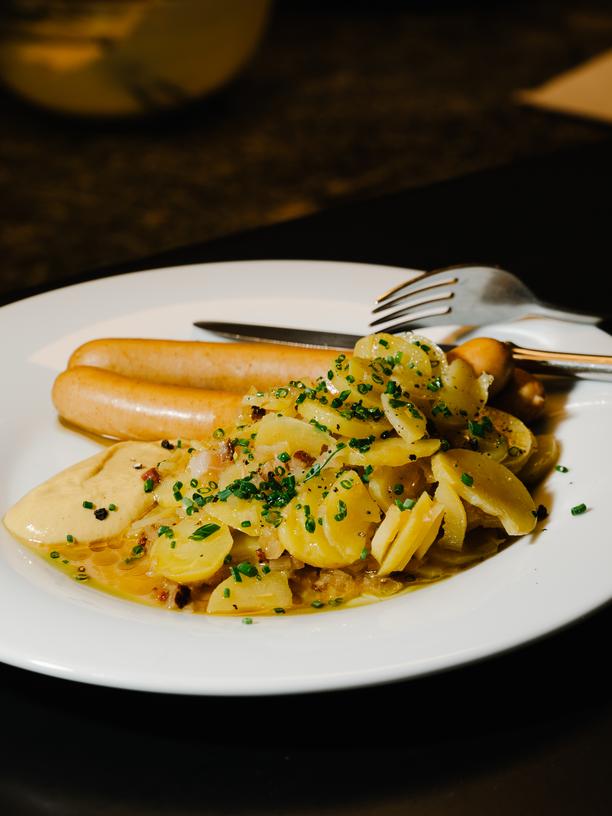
top-left (193, 320), bottom-right (612, 382)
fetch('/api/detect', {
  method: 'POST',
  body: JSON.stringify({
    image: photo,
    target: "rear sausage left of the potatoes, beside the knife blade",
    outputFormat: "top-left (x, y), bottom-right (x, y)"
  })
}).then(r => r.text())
top-left (68, 338), bottom-right (339, 393)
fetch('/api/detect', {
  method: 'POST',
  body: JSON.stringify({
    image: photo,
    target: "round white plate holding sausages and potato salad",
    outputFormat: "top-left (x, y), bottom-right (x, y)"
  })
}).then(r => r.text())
top-left (0, 261), bottom-right (612, 695)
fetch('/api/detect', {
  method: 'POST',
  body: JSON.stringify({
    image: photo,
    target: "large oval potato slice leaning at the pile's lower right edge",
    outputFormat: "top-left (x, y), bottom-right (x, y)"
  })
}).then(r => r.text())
top-left (431, 450), bottom-right (536, 535)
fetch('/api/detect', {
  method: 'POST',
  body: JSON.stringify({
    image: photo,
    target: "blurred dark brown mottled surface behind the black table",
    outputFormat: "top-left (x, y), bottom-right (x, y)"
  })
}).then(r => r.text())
top-left (0, 0), bottom-right (612, 294)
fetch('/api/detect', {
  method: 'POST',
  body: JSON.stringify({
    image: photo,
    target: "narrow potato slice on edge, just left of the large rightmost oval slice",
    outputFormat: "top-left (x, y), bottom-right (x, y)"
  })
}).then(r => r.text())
top-left (378, 493), bottom-right (444, 575)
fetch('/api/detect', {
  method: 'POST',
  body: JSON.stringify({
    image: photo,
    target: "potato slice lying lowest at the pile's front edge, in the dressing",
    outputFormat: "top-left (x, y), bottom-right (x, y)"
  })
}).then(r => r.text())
top-left (207, 572), bottom-right (293, 615)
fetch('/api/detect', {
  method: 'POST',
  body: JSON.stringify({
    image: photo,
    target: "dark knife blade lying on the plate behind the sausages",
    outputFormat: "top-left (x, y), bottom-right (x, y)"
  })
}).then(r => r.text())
top-left (193, 320), bottom-right (360, 351)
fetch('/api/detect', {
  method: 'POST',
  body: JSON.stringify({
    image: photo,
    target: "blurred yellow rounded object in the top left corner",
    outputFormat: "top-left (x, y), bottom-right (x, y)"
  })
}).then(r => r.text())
top-left (0, 0), bottom-right (271, 116)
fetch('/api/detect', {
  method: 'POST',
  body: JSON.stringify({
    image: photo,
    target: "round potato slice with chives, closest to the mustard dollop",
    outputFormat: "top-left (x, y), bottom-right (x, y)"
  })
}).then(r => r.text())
top-left (151, 516), bottom-right (233, 584)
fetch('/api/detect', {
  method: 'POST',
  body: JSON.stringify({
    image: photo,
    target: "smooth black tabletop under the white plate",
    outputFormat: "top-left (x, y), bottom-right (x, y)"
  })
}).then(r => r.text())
top-left (0, 140), bottom-right (612, 816)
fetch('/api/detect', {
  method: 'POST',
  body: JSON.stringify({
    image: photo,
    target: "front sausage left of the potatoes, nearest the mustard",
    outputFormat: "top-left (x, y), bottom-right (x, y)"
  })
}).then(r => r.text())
top-left (52, 366), bottom-right (242, 440)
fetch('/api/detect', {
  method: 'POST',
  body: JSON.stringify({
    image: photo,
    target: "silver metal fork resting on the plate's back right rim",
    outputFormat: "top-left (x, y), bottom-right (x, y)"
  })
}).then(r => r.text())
top-left (370, 264), bottom-right (605, 333)
